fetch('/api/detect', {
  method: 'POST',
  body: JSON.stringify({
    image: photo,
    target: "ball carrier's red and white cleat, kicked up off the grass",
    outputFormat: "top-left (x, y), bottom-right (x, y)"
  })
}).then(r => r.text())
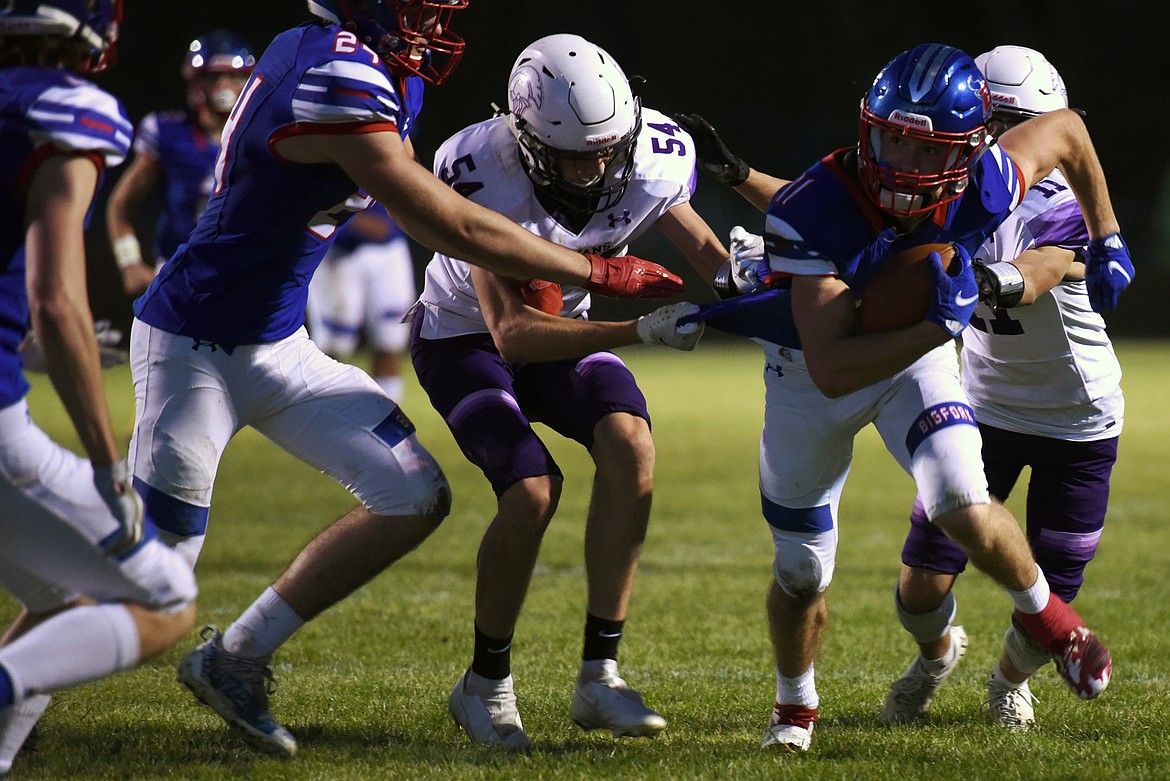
top-left (1012, 594), bottom-right (1113, 699)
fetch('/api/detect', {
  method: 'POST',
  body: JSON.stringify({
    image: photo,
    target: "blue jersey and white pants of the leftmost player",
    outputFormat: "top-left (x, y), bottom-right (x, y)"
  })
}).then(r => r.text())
top-left (0, 67), bottom-right (195, 613)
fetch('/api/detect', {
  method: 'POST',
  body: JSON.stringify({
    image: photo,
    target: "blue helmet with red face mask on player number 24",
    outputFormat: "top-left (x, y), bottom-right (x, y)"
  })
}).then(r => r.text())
top-left (308, 0), bottom-right (468, 84)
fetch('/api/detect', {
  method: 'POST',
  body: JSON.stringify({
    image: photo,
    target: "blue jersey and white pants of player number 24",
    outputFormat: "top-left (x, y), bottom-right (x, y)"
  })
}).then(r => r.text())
top-left (130, 22), bottom-right (446, 560)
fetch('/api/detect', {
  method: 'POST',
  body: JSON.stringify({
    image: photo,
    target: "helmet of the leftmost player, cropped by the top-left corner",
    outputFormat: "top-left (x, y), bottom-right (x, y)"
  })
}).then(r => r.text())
top-left (0, 0), bottom-right (122, 74)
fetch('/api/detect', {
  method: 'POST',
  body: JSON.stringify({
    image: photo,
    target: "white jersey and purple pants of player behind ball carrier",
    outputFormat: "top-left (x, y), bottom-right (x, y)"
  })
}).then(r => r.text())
top-left (902, 171), bottom-right (1124, 602)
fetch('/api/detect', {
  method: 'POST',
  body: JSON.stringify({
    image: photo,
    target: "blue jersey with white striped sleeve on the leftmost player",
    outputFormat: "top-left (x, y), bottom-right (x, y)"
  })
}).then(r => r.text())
top-left (0, 67), bottom-right (133, 407)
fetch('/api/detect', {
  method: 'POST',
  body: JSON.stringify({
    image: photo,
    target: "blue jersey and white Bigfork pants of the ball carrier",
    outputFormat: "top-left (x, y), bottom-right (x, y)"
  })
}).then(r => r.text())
top-left (757, 145), bottom-right (1024, 596)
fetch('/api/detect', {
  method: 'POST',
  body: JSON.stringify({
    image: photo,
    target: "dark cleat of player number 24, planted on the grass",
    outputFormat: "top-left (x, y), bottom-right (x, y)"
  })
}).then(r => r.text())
top-left (179, 627), bottom-right (296, 756)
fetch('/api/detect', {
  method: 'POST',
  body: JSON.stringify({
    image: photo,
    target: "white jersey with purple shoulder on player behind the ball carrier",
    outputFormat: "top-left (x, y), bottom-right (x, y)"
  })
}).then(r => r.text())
top-left (962, 171), bottom-right (1124, 441)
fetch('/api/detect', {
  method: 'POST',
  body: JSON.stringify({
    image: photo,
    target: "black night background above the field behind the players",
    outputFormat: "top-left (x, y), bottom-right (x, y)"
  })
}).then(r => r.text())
top-left (88, 0), bottom-right (1170, 336)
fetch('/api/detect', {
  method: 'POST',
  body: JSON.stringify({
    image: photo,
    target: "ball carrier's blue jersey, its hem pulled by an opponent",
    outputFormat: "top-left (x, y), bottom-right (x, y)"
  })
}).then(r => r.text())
top-left (736, 145), bottom-right (1024, 348)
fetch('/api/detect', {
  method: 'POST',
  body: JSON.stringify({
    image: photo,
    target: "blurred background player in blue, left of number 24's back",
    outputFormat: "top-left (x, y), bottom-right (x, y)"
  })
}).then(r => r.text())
top-left (105, 30), bottom-right (256, 297)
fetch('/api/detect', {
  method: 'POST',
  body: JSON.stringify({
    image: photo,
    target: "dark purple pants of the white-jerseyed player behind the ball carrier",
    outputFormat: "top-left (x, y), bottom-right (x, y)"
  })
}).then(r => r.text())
top-left (902, 423), bottom-right (1117, 602)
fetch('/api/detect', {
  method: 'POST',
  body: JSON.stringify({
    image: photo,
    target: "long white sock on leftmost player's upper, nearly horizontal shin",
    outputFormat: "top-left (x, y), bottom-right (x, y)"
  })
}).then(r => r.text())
top-left (0, 604), bottom-right (138, 699)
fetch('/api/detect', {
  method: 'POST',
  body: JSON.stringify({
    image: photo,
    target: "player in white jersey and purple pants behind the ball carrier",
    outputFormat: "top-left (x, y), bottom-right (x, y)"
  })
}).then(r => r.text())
top-left (881, 46), bottom-right (1124, 731)
